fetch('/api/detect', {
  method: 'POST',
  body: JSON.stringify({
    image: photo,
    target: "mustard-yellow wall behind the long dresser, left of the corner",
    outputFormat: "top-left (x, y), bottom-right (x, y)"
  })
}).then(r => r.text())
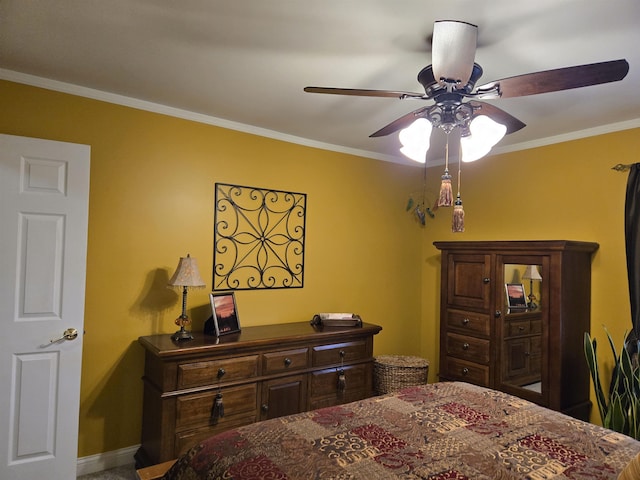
top-left (0, 82), bottom-right (422, 456)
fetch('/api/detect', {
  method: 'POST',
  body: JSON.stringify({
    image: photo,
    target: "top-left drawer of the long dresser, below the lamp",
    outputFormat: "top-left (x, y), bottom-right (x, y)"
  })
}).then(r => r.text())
top-left (178, 355), bottom-right (258, 389)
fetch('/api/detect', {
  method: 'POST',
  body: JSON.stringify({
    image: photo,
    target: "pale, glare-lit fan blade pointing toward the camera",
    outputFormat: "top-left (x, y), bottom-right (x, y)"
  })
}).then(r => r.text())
top-left (431, 20), bottom-right (478, 85)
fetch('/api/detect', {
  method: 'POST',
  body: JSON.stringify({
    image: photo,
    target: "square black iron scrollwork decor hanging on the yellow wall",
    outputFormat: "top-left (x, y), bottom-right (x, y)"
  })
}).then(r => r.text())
top-left (213, 183), bottom-right (307, 290)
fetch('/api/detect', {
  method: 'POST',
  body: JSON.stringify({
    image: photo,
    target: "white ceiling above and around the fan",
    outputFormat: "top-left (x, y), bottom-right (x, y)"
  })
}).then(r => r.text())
top-left (0, 0), bottom-right (640, 163)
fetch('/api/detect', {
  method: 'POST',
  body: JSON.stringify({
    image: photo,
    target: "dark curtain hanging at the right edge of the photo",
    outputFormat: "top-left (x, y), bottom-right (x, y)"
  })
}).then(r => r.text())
top-left (624, 163), bottom-right (640, 353)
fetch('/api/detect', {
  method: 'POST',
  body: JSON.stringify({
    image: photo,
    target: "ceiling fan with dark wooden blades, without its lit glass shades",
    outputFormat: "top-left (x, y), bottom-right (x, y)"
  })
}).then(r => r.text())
top-left (304, 20), bottom-right (629, 161)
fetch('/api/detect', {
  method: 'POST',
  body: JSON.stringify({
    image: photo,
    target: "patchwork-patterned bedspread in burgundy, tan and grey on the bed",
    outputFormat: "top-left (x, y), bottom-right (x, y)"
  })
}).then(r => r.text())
top-left (163, 383), bottom-right (640, 480)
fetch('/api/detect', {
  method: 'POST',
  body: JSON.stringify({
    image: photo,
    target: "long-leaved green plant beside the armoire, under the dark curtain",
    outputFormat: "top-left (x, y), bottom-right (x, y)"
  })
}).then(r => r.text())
top-left (584, 328), bottom-right (640, 439)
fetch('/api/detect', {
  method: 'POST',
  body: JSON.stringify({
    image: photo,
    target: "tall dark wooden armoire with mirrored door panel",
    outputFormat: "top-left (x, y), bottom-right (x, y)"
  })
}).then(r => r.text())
top-left (434, 240), bottom-right (598, 420)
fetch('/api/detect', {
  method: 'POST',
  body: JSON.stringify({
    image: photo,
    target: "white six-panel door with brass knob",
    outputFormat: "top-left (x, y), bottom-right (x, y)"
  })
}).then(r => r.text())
top-left (0, 135), bottom-right (90, 480)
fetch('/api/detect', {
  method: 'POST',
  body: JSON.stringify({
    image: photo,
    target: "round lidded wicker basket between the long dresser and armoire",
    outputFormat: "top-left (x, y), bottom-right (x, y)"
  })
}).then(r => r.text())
top-left (373, 355), bottom-right (429, 395)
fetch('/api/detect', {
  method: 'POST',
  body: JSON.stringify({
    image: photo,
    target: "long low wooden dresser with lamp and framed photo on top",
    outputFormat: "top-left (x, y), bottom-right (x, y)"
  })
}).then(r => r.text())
top-left (136, 322), bottom-right (381, 467)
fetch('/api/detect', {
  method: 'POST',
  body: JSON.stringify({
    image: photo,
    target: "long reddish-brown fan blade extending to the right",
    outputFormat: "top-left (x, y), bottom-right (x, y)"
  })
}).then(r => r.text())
top-left (477, 59), bottom-right (629, 98)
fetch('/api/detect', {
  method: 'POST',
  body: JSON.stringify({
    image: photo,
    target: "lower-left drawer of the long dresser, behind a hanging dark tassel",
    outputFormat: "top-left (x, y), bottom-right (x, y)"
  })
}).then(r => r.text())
top-left (176, 383), bottom-right (258, 429)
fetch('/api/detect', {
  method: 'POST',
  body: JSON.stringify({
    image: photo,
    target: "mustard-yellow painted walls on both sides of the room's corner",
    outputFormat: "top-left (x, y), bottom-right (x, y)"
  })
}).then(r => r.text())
top-left (0, 81), bottom-right (640, 456)
